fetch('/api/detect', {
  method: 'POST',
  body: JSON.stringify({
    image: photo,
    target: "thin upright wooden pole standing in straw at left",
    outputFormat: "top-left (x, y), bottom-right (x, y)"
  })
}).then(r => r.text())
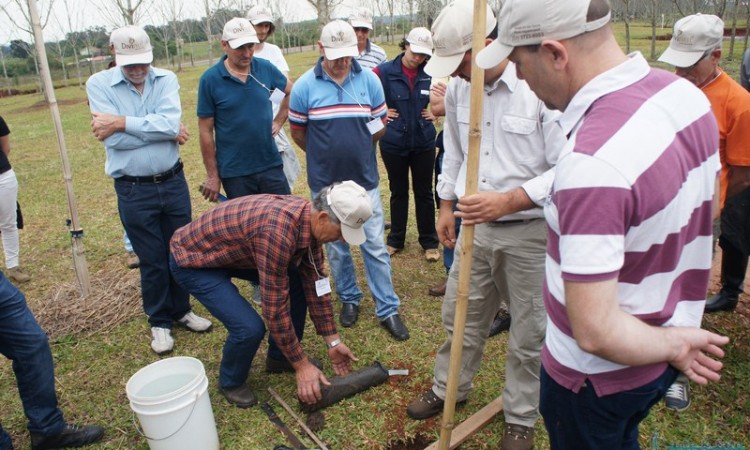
top-left (28, 0), bottom-right (91, 297)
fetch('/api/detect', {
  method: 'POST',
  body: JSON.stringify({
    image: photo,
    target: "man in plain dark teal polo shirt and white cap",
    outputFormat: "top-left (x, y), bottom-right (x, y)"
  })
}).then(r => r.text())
top-left (198, 17), bottom-right (292, 201)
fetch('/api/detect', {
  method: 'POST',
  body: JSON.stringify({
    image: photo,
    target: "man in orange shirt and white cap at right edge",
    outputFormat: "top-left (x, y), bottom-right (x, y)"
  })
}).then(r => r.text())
top-left (659, 14), bottom-right (750, 411)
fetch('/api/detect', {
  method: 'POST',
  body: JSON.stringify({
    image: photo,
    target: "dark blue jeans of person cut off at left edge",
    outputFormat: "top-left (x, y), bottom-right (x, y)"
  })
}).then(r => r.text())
top-left (0, 273), bottom-right (65, 449)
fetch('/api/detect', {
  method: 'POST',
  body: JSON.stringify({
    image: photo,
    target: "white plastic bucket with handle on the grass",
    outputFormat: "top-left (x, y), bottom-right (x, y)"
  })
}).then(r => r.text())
top-left (125, 356), bottom-right (219, 450)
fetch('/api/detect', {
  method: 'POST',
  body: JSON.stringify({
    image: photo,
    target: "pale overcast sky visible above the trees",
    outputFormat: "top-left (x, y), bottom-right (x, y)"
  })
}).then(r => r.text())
top-left (0, 0), bottom-right (334, 43)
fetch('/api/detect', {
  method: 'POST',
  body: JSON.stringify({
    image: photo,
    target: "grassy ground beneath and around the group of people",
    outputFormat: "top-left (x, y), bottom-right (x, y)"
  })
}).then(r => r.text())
top-left (0, 23), bottom-right (750, 450)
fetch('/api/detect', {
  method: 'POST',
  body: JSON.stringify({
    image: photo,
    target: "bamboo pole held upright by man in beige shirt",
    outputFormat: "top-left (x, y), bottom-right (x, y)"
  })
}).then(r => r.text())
top-left (438, 0), bottom-right (488, 450)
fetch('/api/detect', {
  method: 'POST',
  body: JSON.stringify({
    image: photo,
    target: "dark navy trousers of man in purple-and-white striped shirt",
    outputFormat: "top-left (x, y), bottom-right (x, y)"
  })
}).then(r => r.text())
top-left (539, 366), bottom-right (678, 450)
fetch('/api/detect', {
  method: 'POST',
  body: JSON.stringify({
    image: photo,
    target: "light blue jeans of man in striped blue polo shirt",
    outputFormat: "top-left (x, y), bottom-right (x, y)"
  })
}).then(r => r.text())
top-left (324, 188), bottom-right (401, 320)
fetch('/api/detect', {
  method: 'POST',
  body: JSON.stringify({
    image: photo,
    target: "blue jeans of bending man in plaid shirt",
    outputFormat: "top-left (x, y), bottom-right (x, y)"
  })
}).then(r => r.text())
top-left (169, 255), bottom-right (307, 389)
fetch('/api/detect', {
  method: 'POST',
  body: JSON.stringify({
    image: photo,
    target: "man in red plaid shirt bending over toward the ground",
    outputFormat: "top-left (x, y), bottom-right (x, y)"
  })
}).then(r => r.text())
top-left (170, 181), bottom-right (372, 408)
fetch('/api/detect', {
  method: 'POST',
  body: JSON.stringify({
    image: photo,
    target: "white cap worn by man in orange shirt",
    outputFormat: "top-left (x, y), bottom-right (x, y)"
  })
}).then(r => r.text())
top-left (659, 14), bottom-right (724, 67)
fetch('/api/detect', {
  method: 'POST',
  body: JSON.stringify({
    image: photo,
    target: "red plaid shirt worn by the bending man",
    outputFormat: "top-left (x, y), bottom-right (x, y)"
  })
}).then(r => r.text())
top-left (170, 195), bottom-right (336, 362)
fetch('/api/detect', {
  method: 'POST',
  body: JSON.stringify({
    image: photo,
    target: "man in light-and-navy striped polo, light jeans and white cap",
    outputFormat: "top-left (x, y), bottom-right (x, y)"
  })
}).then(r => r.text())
top-left (289, 20), bottom-right (409, 340)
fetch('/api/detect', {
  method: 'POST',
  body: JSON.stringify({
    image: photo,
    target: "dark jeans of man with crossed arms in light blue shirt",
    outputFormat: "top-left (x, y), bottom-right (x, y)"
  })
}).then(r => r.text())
top-left (115, 172), bottom-right (192, 328)
